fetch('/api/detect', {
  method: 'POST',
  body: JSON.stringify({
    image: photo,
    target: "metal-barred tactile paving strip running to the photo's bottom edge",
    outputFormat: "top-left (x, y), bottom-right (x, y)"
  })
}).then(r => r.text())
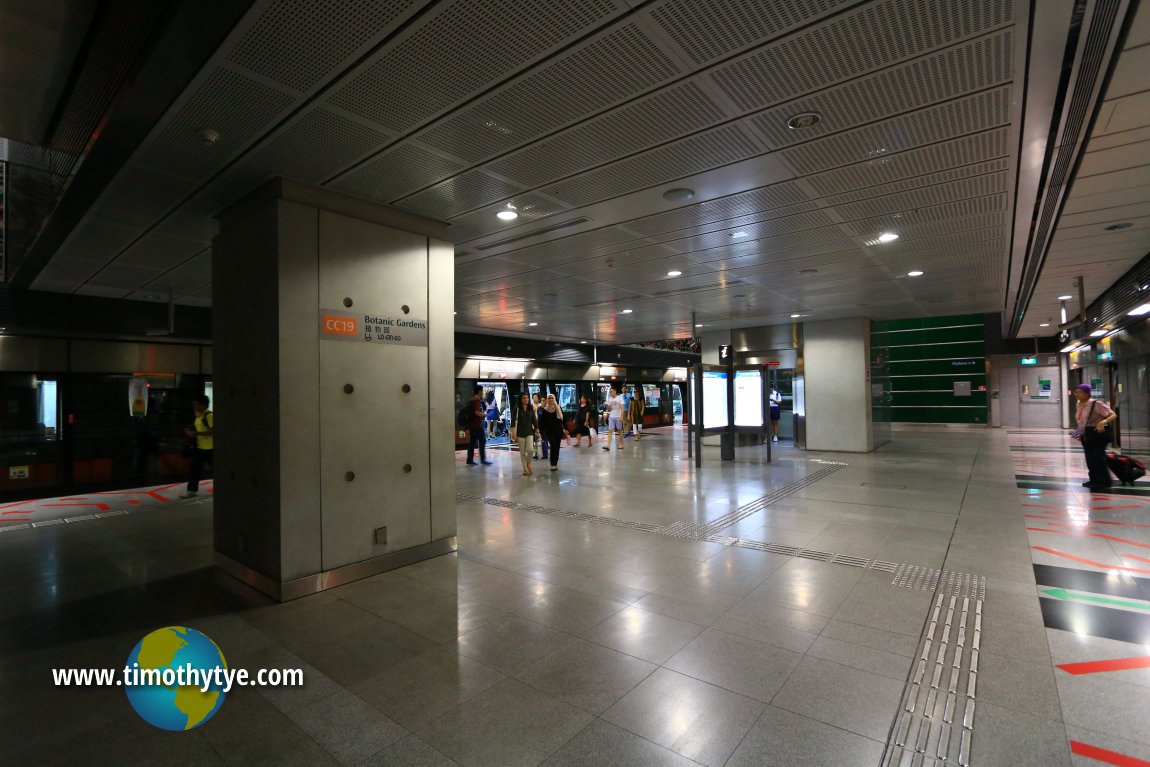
top-left (880, 593), bottom-right (986, 767)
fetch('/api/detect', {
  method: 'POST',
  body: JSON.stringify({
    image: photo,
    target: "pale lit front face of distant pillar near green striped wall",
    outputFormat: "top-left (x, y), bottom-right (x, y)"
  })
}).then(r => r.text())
top-left (803, 319), bottom-right (875, 453)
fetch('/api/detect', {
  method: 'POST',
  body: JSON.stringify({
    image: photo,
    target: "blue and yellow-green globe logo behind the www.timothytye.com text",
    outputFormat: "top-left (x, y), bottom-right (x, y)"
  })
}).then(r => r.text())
top-left (123, 626), bottom-right (228, 731)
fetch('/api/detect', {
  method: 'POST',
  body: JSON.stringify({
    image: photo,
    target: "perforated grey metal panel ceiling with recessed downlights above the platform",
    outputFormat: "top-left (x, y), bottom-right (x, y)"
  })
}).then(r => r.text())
top-left (31, 0), bottom-right (1136, 340)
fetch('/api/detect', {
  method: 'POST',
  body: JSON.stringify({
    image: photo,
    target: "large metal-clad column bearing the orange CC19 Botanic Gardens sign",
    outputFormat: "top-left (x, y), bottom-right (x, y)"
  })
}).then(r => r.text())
top-left (212, 179), bottom-right (457, 601)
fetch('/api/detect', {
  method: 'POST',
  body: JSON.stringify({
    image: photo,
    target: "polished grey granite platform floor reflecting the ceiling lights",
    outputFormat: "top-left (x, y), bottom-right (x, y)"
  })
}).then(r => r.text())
top-left (0, 428), bottom-right (1150, 767)
